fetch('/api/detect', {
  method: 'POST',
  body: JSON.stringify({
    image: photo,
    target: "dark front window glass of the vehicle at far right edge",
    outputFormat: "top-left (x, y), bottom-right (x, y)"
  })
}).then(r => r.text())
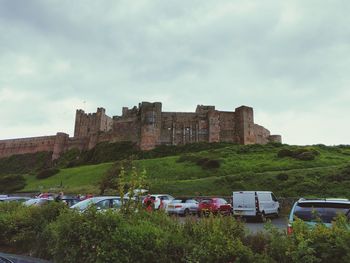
top-left (294, 202), bottom-right (350, 223)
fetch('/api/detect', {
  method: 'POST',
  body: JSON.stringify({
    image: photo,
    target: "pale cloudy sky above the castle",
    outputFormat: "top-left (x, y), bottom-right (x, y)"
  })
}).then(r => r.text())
top-left (0, 0), bottom-right (350, 145)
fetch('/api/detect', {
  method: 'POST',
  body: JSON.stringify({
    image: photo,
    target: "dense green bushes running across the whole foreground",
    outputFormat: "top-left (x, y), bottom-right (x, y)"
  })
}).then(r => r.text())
top-left (0, 202), bottom-right (350, 263)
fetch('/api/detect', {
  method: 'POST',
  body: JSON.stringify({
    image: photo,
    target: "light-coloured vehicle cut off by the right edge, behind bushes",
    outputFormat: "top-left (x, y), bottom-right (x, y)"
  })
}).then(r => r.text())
top-left (287, 198), bottom-right (350, 234)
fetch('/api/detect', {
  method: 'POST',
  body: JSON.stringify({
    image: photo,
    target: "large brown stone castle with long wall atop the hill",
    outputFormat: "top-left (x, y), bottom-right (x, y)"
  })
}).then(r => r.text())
top-left (0, 102), bottom-right (281, 160)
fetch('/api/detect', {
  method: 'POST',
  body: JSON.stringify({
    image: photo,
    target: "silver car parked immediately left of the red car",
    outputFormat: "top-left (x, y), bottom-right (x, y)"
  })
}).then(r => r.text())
top-left (165, 198), bottom-right (199, 216)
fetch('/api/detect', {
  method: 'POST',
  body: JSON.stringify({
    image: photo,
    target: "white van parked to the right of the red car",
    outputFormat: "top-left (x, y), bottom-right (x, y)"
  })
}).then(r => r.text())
top-left (232, 191), bottom-right (280, 221)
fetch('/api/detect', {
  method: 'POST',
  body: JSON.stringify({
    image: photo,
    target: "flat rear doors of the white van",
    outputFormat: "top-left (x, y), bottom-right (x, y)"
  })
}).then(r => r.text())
top-left (232, 192), bottom-right (256, 216)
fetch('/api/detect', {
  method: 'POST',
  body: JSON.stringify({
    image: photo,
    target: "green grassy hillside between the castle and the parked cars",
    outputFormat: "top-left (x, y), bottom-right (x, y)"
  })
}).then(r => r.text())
top-left (17, 144), bottom-right (350, 198)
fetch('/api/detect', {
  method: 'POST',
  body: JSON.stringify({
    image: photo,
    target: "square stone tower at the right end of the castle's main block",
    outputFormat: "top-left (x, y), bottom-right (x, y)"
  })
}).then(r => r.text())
top-left (235, 106), bottom-right (255, 144)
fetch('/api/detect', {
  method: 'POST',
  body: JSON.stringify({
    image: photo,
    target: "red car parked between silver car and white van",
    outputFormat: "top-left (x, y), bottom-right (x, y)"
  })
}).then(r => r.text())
top-left (198, 198), bottom-right (232, 216)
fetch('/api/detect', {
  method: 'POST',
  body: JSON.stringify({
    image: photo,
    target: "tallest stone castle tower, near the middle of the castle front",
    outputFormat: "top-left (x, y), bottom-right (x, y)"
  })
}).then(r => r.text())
top-left (139, 102), bottom-right (162, 150)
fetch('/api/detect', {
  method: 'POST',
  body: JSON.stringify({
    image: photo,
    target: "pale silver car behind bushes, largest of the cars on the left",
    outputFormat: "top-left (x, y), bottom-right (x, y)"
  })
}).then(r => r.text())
top-left (70, 196), bottom-right (126, 212)
